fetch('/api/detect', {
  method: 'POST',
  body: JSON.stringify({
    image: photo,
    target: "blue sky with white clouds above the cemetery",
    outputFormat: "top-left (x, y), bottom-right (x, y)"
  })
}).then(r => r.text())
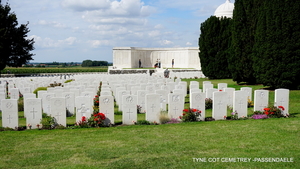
top-left (2, 0), bottom-right (234, 62)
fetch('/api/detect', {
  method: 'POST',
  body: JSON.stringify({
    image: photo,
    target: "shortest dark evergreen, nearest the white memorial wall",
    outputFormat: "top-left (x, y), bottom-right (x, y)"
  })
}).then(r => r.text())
top-left (199, 16), bottom-right (231, 79)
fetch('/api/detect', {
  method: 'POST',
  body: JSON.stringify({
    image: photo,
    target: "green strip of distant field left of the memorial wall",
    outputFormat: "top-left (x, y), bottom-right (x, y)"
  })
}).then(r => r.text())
top-left (1, 66), bottom-right (108, 74)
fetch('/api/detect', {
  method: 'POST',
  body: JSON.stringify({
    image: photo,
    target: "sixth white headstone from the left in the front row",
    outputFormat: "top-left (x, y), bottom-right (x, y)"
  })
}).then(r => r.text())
top-left (122, 95), bottom-right (137, 124)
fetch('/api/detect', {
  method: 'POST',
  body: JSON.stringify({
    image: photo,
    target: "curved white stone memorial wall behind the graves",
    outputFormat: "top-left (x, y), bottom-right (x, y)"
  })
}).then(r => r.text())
top-left (113, 47), bottom-right (201, 70)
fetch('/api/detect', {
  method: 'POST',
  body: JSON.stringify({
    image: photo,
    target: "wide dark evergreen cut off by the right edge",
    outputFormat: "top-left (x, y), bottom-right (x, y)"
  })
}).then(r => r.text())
top-left (253, 0), bottom-right (300, 89)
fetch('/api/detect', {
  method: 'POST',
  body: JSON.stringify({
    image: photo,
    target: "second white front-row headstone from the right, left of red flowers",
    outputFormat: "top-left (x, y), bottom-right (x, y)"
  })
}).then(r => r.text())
top-left (254, 90), bottom-right (269, 111)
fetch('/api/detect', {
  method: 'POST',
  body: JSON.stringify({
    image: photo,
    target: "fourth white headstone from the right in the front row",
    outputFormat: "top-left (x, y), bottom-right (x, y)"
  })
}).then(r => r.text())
top-left (212, 91), bottom-right (228, 120)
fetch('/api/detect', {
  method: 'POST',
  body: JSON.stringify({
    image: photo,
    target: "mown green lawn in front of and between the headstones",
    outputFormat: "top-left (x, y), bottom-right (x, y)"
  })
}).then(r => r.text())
top-left (0, 79), bottom-right (300, 168)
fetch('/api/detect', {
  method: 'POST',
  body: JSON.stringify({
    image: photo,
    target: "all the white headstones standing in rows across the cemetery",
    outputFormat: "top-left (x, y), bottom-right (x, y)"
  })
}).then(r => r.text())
top-left (0, 75), bottom-right (289, 129)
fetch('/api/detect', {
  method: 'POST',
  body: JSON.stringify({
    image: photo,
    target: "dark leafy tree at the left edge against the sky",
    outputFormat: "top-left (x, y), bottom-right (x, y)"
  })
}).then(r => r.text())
top-left (0, 0), bottom-right (34, 70)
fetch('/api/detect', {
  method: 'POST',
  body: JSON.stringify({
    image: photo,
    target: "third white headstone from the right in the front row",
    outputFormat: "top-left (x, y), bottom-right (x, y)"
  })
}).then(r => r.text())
top-left (233, 91), bottom-right (248, 118)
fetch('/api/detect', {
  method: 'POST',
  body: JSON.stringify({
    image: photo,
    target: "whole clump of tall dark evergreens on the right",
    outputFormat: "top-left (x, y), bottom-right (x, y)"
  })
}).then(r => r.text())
top-left (199, 0), bottom-right (300, 89)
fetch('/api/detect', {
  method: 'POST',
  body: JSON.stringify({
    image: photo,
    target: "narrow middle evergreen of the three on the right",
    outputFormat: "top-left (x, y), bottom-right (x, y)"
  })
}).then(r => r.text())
top-left (228, 0), bottom-right (257, 84)
